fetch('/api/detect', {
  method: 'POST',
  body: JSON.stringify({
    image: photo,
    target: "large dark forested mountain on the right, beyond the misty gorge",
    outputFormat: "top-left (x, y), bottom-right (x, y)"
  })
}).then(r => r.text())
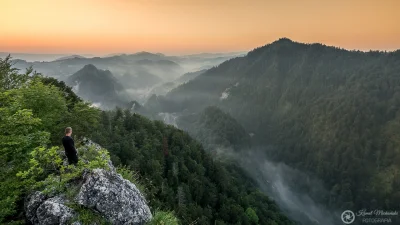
top-left (147, 39), bottom-right (400, 209)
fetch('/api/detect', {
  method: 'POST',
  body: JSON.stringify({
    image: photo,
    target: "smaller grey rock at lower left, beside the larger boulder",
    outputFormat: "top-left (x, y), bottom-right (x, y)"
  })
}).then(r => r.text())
top-left (25, 192), bottom-right (75, 225)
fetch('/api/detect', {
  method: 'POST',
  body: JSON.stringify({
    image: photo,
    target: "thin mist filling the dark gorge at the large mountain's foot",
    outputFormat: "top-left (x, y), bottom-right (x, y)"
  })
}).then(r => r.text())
top-left (236, 149), bottom-right (342, 225)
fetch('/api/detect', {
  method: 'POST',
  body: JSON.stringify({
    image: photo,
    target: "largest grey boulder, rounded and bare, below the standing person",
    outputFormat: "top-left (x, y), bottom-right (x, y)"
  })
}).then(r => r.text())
top-left (77, 169), bottom-right (152, 225)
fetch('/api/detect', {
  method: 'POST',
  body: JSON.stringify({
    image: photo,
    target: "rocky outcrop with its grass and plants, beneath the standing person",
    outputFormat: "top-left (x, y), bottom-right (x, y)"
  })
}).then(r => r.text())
top-left (24, 140), bottom-right (152, 225)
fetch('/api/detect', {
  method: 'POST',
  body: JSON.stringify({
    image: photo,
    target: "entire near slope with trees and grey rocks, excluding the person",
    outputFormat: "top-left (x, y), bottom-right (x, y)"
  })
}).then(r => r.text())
top-left (0, 56), bottom-right (292, 225)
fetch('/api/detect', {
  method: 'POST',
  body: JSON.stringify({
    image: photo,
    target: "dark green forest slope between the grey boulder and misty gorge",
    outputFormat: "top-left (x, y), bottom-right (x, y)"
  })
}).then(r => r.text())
top-left (93, 109), bottom-right (291, 225)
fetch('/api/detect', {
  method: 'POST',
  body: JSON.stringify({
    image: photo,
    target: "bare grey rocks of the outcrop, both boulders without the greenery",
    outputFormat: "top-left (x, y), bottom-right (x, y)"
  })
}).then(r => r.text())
top-left (25, 140), bottom-right (152, 225)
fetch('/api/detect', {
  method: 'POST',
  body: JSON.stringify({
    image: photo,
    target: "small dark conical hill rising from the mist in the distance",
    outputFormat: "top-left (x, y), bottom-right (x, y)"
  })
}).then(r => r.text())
top-left (66, 64), bottom-right (124, 108)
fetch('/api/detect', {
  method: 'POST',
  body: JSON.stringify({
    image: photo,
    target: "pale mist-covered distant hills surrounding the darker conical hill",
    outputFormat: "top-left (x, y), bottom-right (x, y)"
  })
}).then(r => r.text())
top-left (4, 52), bottom-right (245, 109)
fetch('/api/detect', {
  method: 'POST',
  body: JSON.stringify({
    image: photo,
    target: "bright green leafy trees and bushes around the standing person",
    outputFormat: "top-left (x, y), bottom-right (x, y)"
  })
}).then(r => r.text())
top-left (0, 57), bottom-right (101, 224)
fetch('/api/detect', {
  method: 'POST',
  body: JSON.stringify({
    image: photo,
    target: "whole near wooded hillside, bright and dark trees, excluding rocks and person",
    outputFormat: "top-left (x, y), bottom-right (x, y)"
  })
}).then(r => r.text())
top-left (0, 55), bottom-right (292, 225)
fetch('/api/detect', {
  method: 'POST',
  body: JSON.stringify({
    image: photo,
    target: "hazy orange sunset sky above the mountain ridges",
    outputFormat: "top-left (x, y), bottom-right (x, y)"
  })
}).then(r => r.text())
top-left (0, 0), bottom-right (400, 54)
